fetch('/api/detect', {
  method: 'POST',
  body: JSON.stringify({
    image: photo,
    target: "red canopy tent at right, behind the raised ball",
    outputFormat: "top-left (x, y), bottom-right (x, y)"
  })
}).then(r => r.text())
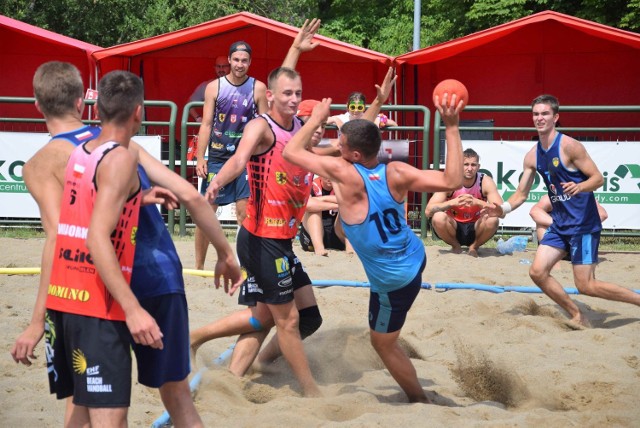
top-left (395, 11), bottom-right (640, 135)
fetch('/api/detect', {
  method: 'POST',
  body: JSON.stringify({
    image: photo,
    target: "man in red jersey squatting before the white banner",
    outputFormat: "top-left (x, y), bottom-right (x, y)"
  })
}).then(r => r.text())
top-left (425, 149), bottom-right (502, 257)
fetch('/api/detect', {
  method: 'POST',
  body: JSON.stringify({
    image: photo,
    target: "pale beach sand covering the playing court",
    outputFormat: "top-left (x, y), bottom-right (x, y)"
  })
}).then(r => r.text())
top-left (0, 238), bottom-right (640, 427)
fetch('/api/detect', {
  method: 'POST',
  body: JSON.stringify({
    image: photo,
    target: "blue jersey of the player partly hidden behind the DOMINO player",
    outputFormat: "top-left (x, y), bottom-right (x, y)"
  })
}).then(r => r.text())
top-left (131, 165), bottom-right (185, 300)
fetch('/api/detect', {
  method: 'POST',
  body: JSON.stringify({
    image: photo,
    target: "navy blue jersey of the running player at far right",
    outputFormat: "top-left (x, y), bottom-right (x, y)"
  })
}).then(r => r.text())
top-left (536, 132), bottom-right (602, 235)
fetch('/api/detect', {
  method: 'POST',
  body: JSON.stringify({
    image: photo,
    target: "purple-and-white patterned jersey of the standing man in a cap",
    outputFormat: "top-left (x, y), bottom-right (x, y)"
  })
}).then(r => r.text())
top-left (207, 77), bottom-right (258, 162)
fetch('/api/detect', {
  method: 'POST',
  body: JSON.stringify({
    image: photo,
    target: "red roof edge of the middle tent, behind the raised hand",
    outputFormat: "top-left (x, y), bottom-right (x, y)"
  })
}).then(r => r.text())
top-left (92, 12), bottom-right (393, 63)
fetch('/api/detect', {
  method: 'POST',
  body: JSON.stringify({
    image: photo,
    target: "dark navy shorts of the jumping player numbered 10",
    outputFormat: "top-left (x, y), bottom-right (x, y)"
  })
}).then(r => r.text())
top-left (369, 256), bottom-right (427, 333)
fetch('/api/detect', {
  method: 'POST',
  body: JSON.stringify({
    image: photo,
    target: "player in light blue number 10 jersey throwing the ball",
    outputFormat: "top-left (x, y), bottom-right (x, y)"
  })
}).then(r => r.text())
top-left (283, 69), bottom-right (463, 403)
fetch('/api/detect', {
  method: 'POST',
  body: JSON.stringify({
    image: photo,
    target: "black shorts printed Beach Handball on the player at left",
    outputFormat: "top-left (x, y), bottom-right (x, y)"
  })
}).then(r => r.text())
top-left (45, 309), bottom-right (131, 408)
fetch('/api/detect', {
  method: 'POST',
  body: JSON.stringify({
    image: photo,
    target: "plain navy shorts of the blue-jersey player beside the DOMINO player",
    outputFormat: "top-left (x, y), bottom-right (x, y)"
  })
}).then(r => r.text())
top-left (131, 293), bottom-right (191, 388)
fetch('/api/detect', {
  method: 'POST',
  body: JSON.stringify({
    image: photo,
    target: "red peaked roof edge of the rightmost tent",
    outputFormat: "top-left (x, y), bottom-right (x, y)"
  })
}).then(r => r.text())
top-left (394, 11), bottom-right (640, 64)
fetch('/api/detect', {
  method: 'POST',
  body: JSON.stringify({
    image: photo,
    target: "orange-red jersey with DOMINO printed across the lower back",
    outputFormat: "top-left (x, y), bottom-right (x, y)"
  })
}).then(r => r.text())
top-left (46, 142), bottom-right (141, 321)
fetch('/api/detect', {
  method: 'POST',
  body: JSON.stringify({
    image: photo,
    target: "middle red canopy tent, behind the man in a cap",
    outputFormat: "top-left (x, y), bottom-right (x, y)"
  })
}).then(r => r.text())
top-left (93, 12), bottom-right (392, 132)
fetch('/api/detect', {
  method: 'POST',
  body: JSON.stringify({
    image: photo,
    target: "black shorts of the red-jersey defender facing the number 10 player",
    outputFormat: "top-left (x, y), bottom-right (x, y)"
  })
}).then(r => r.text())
top-left (237, 227), bottom-right (311, 306)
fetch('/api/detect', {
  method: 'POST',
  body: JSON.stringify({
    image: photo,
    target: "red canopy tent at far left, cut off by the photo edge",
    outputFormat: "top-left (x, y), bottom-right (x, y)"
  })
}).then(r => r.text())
top-left (0, 15), bottom-right (101, 123)
